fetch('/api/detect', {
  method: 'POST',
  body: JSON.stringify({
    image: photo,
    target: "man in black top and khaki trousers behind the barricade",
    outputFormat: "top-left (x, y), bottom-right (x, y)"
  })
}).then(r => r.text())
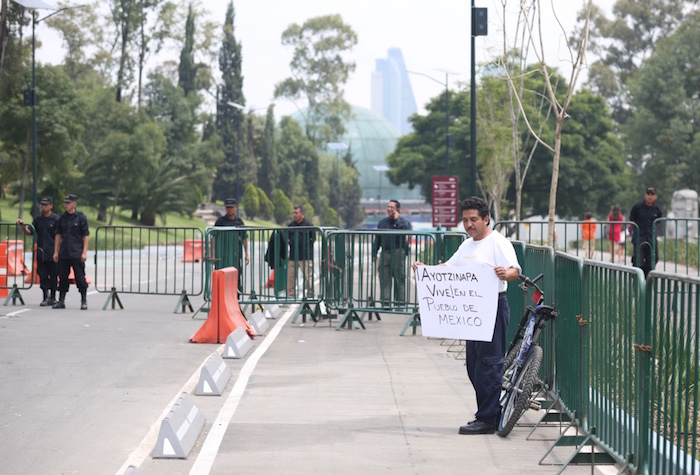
top-left (287, 206), bottom-right (316, 298)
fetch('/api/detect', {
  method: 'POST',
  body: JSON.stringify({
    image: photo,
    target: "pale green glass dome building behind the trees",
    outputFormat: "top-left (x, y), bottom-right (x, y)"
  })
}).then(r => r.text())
top-left (292, 106), bottom-right (423, 203)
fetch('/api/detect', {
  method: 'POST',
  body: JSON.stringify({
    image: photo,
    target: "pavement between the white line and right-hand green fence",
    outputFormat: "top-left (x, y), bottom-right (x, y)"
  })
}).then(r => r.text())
top-left (135, 310), bottom-right (615, 475)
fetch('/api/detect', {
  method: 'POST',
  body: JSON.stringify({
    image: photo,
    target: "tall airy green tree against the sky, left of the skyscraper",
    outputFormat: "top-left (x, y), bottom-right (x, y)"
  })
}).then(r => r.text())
top-left (275, 15), bottom-right (357, 146)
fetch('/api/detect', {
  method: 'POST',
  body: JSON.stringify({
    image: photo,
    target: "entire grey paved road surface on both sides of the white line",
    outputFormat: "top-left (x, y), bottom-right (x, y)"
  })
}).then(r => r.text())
top-left (0, 289), bottom-right (615, 475)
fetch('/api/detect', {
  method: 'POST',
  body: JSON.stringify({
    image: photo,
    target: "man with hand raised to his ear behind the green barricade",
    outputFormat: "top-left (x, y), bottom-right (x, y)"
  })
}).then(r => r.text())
top-left (372, 200), bottom-right (412, 307)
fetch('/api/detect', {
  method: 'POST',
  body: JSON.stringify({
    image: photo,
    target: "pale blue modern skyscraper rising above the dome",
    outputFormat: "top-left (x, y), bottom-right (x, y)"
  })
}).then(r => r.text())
top-left (372, 48), bottom-right (418, 135)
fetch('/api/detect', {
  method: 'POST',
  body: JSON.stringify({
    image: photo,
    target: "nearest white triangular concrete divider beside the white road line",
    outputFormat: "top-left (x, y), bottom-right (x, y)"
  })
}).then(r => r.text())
top-left (153, 393), bottom-right (205, 459)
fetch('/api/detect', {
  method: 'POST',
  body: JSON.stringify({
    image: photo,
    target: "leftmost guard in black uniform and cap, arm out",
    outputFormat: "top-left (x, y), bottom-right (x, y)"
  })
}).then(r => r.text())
top-left (17, 196), bottom-right (58, 307)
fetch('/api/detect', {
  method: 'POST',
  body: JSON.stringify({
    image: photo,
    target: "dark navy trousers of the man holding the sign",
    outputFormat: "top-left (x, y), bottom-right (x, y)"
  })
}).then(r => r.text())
top-left (467, 295), bottom-right (510, 427)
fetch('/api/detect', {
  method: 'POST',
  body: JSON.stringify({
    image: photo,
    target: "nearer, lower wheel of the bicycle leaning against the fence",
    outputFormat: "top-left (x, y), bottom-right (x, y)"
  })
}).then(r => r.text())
top-left (498, 345), bottom-right (542, 437)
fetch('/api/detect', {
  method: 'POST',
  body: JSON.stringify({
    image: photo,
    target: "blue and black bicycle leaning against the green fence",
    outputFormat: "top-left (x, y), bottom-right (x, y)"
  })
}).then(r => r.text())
top-left (498, 274), bottom-right (557, 437)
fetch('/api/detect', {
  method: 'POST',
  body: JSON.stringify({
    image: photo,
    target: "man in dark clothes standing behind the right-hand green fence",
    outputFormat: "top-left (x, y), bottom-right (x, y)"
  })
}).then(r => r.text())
top-left (630, 186), bottom-right (663, 277)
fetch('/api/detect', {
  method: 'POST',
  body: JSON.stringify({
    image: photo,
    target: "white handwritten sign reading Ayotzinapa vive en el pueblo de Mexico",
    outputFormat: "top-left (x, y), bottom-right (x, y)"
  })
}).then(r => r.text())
top-left (416, 262), bottom-right (498, 341)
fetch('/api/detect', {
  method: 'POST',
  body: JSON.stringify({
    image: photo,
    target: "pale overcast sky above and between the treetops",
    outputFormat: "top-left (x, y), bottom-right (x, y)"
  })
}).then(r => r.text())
top-left (30, 0), bottom-right (600, 117)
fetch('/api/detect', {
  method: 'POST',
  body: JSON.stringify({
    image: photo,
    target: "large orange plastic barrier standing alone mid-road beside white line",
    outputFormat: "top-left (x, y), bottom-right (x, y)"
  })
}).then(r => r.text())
top-left (190, 267), bottom-right (257, 343)
